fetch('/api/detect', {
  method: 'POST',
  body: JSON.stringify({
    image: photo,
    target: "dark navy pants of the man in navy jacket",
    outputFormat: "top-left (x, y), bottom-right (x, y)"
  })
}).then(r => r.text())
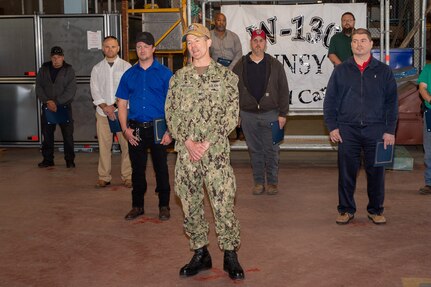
top-left (338, 125), bottom-right (385, 214)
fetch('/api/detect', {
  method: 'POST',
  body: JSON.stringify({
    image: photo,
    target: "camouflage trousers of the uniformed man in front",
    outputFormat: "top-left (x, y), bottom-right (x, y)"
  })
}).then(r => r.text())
top-left (175, 146), bottom-right (240, 250)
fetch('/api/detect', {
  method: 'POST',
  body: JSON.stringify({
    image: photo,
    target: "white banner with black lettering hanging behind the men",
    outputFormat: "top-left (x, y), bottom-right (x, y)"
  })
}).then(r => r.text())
top-left (221, 3), bottom-right (367, 114)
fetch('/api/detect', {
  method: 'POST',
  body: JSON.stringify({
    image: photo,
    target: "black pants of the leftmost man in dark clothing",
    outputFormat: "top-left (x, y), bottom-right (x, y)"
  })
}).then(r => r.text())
top-left (41, 105), bottom-right (75, 163)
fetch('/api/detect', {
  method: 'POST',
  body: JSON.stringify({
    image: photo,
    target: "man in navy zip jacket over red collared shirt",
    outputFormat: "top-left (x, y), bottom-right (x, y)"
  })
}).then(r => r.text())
top-left (323, 28), bottom-right (398, 224)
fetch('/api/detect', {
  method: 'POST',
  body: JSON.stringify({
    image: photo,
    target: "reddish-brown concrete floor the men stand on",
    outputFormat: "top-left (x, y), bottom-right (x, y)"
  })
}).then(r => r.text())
top-left (0, 147), bottom-right (431, 287)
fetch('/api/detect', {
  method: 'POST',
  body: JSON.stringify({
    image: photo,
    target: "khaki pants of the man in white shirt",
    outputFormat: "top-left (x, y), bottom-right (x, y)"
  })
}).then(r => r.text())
top-left (96, 112), bottom-right (132, 182)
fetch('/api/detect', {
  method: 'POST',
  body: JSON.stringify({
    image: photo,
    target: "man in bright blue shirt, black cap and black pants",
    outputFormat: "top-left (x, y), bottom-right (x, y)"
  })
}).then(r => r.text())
top-left (116, 32), bottom-right (172, 220)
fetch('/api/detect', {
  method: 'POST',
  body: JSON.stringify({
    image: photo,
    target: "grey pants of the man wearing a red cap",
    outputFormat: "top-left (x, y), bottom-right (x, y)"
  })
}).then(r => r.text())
top-left (240, 110), bottom-right (280, 184)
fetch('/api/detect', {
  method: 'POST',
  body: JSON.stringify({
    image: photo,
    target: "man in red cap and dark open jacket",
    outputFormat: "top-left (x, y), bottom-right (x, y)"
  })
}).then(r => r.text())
top-left (233, 29), bottom-right (289, 195)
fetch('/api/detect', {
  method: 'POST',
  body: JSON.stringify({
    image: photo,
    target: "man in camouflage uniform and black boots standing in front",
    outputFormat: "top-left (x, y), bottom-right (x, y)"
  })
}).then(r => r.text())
top-left (165, 24), bottom-right (244, 280)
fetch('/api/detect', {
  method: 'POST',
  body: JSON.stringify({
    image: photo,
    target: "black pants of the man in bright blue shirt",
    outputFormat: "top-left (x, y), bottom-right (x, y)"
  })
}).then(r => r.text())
top-left (129, 124), bottom-right (171, 207)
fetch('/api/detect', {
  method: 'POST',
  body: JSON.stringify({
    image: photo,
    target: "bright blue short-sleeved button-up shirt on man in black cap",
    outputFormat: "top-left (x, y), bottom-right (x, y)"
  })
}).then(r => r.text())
top-left (116, 59), bottom-right (172, 122)
